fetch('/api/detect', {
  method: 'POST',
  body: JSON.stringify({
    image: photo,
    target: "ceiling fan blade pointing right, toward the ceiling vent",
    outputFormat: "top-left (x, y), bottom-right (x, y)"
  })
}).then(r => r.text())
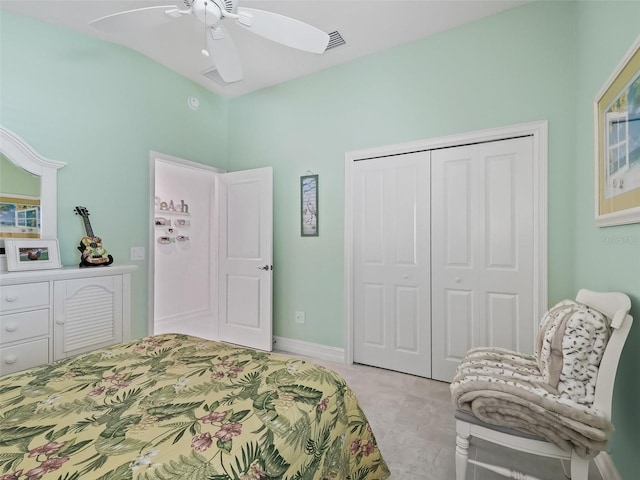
top-left (237, 7), bottom-right (329, 53)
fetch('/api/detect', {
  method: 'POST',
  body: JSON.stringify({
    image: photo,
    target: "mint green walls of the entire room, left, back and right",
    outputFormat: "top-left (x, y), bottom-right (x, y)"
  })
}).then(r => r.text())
top-left (0, 1), bottom-right (640, 478)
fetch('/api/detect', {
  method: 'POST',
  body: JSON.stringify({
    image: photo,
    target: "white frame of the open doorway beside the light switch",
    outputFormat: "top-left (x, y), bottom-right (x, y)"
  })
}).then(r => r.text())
top-left (147, 150), bottom-right (226, 335)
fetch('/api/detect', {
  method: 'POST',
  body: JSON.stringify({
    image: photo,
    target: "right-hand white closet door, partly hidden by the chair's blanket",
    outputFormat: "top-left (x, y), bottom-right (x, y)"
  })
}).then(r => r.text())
top-left (431, 137), bottom-right (537, 381)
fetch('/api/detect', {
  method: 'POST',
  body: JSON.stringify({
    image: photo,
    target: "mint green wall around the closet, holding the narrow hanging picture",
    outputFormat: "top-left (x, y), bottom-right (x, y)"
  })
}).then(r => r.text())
top-left (229, 2), bottom-right (575, 347)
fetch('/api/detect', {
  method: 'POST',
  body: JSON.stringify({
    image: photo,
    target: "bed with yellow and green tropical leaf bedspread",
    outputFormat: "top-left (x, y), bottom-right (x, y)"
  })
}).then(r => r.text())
top-left (0, 334), bottom-right (390, 480)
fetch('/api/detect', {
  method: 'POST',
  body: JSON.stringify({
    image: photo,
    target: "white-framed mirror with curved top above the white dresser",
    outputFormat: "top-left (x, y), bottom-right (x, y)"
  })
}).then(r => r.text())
top-left (0, 126), bottom-right (65, 254)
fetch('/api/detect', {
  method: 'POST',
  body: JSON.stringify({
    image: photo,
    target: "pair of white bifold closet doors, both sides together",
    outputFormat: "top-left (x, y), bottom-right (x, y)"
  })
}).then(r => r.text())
top-left (353, 137), bottom-right (535, 381)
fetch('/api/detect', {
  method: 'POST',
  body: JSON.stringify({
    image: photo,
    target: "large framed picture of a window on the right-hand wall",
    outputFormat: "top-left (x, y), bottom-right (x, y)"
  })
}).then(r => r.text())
top-left (594, 37), bottom-right (640, 227)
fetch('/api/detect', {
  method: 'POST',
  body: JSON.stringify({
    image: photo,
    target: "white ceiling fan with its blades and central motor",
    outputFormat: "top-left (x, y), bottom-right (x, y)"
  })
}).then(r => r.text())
top-left (89, 0), bottom-right (329, 83)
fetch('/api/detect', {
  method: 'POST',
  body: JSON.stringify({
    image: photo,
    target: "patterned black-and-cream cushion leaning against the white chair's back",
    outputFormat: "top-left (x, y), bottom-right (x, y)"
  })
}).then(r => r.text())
top-left (535, 300), bottom-right (610, 405)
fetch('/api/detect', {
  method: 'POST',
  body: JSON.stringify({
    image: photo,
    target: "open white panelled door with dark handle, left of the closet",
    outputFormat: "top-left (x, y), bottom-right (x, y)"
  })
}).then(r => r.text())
top-left (216, 167), bottom-right (273, 351)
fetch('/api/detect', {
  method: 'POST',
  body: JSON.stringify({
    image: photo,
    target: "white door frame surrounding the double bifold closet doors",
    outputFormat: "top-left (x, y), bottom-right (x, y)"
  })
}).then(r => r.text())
top-left (344, 120), bottom-right (548, 364)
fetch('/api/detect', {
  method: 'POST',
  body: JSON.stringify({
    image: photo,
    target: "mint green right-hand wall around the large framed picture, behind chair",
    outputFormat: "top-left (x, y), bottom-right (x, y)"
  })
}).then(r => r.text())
top-left (574, 1), bottom-right (640, 479)
